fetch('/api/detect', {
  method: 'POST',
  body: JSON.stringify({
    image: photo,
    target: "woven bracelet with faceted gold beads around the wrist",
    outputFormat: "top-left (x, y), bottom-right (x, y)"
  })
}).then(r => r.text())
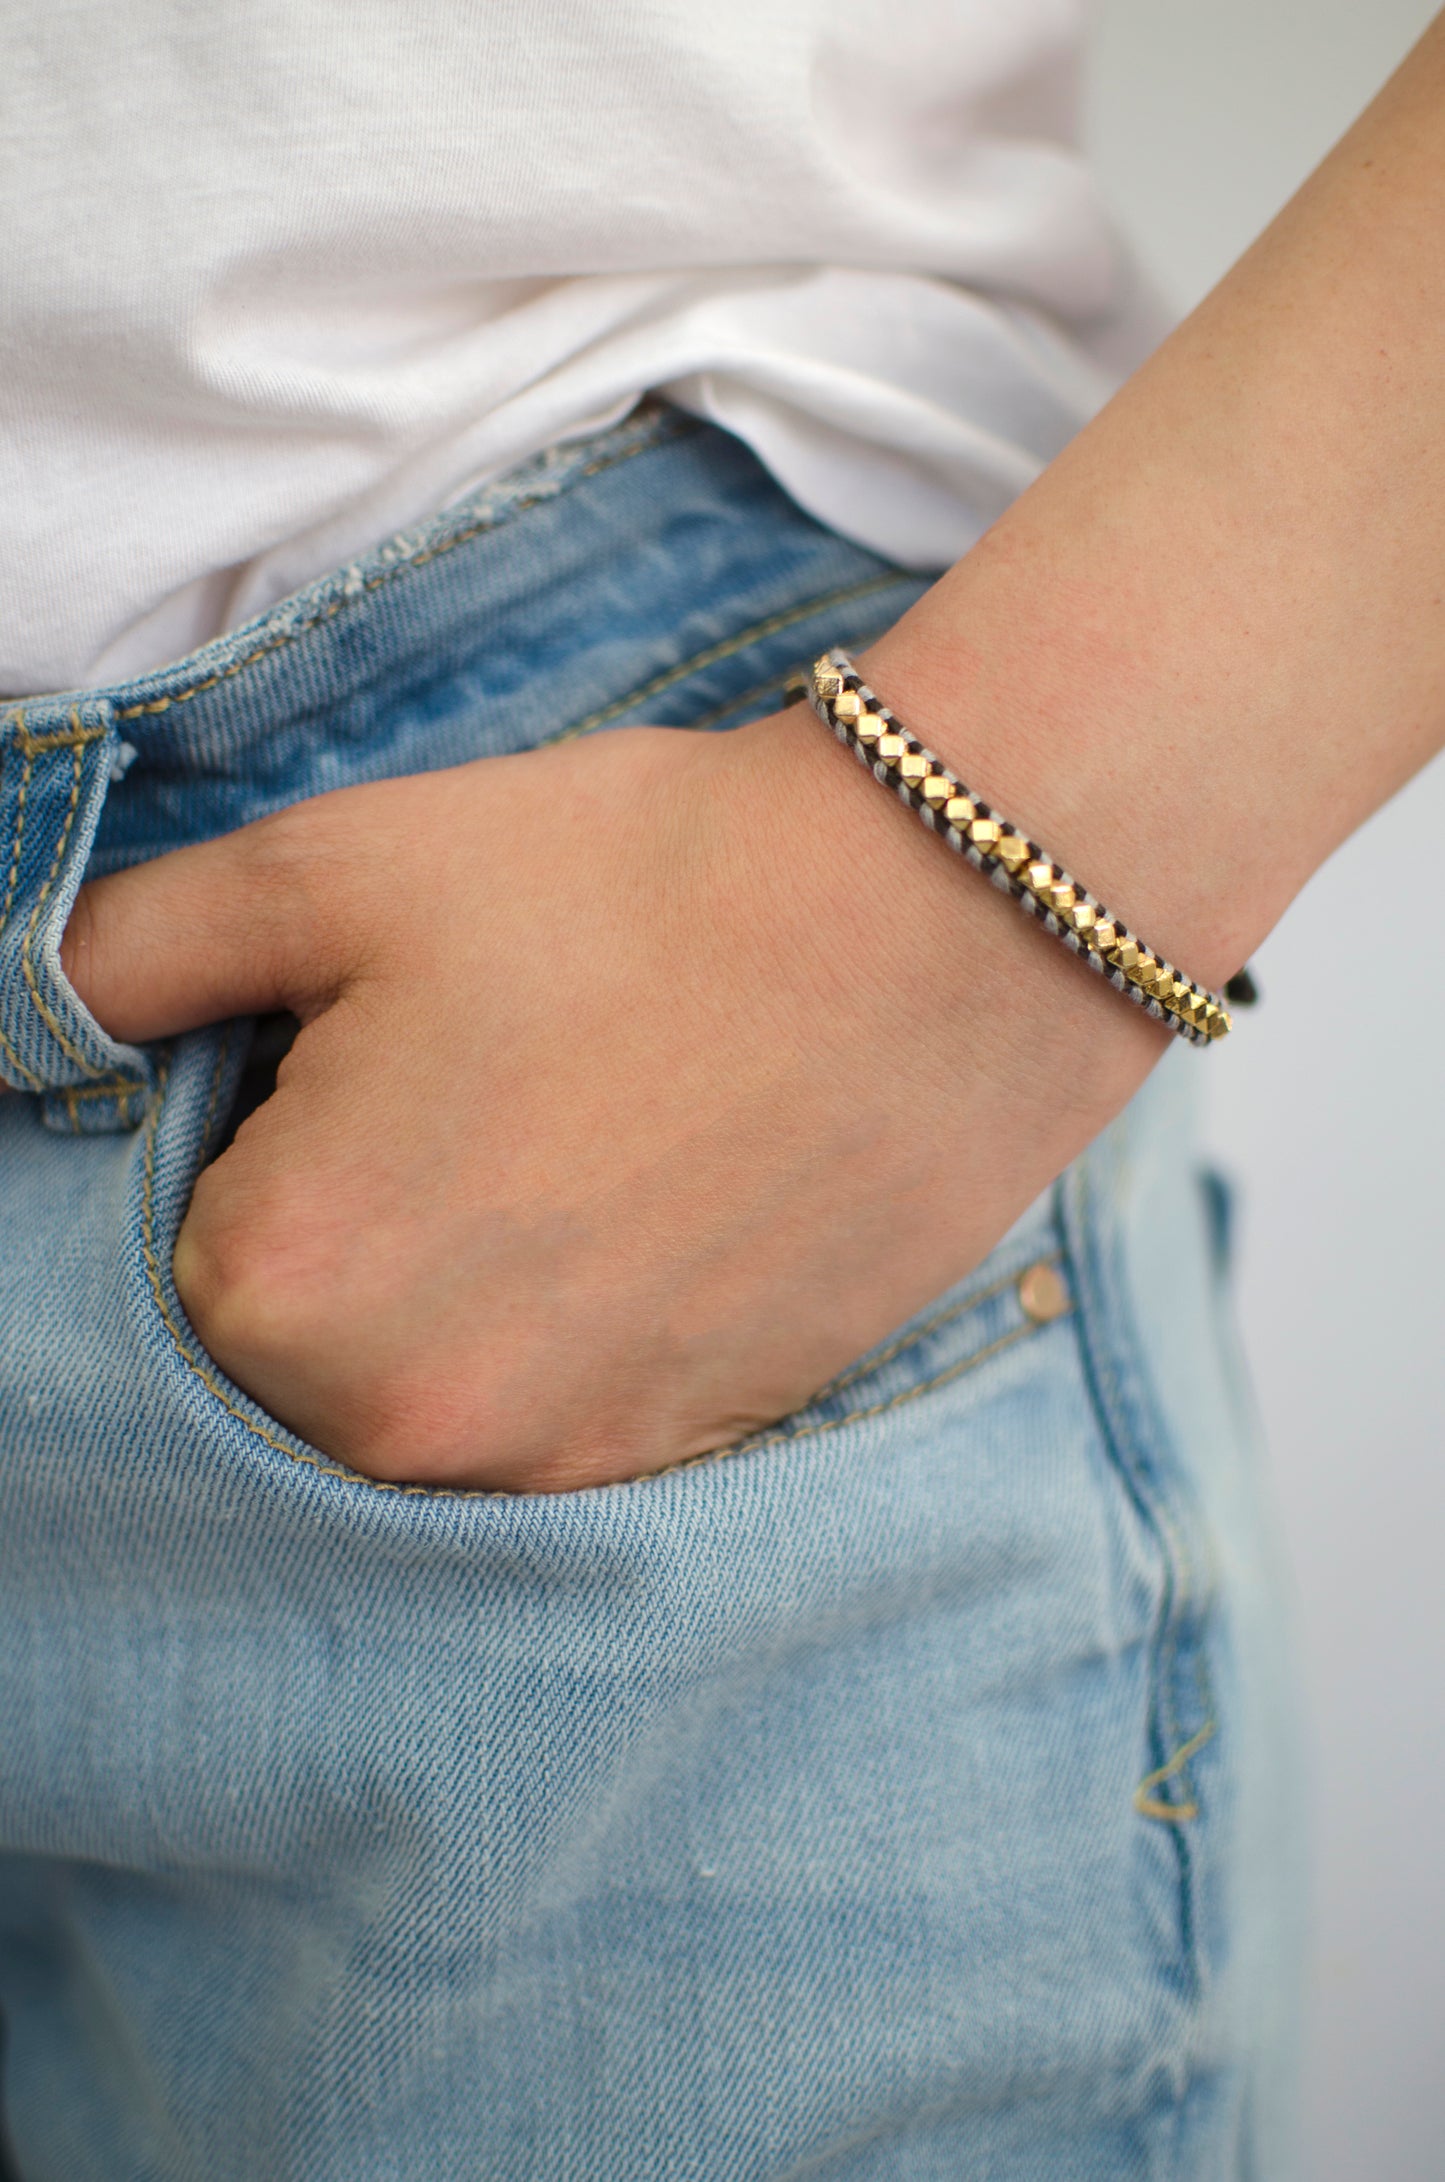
top-left (810, 650), bottom-right (1255, 1045)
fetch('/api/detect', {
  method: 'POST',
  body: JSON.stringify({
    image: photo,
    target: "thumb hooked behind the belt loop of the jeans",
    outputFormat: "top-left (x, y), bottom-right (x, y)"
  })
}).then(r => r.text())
top-left (61, 805), bottom-right (341, 1045)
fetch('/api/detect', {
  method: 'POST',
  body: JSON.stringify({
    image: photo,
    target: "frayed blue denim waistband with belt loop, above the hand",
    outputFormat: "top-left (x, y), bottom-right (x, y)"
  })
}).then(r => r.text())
top-left (0, 401), bottom-right (923, 1132)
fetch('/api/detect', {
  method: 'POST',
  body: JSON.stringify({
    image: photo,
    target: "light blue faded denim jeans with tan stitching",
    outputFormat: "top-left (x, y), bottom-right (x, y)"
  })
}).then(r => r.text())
top-left (0, 406), bottom-right (1299, 2182)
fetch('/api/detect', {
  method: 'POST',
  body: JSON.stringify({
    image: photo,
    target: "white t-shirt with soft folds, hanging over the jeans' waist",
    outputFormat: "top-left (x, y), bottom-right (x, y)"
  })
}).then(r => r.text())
top-left (0, 0), bottom-right (1159, 694)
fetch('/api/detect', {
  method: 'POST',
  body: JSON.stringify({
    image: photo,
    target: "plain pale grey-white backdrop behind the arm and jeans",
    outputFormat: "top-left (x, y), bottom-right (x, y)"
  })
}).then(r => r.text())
top-left (1089, 0), bottom-right (1445, 2182)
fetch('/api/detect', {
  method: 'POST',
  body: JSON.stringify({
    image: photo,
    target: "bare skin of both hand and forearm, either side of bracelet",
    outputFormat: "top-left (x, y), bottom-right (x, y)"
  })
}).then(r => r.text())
top-left (63, 20), bottom-right (1445, 1490)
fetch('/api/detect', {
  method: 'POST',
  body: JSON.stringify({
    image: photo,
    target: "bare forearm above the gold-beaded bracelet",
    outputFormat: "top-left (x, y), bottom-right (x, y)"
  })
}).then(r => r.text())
top-left (851, 20), bottom-right (1445, 997)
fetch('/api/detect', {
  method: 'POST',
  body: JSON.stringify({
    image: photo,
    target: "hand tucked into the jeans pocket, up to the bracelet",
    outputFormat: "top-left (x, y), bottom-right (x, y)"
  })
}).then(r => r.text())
top-left (63, 707), bottom-right (1161, 1490)
